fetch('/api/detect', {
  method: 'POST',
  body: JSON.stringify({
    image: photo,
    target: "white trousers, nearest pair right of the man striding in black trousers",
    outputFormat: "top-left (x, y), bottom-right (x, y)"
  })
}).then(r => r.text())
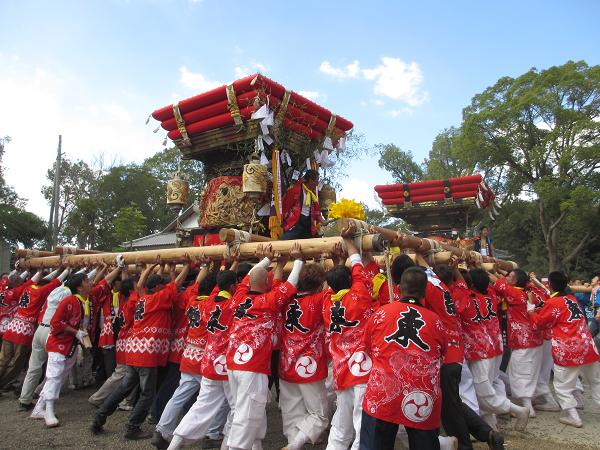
top-left (469, 355), bottom-right (510, 415)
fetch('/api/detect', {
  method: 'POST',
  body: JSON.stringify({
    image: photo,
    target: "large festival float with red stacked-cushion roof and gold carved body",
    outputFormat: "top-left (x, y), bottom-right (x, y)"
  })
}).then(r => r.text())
top-left (152, 74), bottom-right (353, 245)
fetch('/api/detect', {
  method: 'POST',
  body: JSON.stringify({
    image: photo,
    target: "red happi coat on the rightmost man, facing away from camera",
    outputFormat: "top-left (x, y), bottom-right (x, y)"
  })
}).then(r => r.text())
top-left (529, 295), bottom-right (600, 367)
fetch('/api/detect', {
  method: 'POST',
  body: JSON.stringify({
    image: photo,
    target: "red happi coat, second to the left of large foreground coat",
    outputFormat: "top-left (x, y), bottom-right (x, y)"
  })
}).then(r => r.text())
top-left (279, 291), bottom-right (328, 383)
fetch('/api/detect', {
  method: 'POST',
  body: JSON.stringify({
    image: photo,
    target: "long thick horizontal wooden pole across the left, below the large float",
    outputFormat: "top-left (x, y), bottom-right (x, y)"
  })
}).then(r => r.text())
top-left (19, 234), bottom-right (384, 269)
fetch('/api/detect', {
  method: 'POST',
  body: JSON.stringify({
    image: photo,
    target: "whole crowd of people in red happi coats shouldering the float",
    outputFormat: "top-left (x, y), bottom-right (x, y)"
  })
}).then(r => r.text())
top-left (0, 223), bottom-right (600, 450)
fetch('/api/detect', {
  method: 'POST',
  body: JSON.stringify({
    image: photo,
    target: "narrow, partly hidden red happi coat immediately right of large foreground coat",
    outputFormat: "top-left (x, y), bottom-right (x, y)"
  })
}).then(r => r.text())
top-left (423, 276), bottom-right (465, 364)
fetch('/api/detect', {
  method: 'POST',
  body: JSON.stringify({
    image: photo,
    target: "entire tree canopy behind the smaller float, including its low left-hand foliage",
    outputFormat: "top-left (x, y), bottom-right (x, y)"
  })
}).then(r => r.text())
top-left (379, 61), bottom-right (600, 273)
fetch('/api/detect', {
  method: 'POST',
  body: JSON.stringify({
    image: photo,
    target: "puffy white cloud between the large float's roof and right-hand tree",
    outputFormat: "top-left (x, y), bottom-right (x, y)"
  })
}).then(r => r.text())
top-left (319, 57), bottom-right (428, 107)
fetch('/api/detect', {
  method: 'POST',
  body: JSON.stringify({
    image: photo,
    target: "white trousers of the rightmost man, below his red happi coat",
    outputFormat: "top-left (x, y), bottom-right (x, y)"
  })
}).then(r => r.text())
top-left (554, 362), bottom-right (600, 409)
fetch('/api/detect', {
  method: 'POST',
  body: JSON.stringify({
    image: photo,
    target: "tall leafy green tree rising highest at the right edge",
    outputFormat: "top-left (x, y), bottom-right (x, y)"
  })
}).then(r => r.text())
top-left (461, 61), bottom-right (600, 270)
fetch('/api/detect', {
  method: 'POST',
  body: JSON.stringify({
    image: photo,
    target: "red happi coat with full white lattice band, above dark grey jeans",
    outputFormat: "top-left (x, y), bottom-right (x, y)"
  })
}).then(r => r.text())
top-left (127, 282), bottom-right (177, 367)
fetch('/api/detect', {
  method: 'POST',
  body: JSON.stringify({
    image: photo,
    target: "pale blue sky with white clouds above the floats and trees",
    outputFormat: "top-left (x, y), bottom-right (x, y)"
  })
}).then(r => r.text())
top-left (0, 0), bottom-right (600, 217)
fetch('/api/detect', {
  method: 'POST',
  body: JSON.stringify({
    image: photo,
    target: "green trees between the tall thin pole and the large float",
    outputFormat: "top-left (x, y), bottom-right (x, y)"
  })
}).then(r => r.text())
top-left (42, 147), bottom-right (204, 249)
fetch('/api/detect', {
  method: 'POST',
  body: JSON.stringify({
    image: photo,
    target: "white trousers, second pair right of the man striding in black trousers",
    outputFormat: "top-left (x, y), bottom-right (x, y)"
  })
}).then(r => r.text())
top-left (508, 345), bottom-right (544, 399)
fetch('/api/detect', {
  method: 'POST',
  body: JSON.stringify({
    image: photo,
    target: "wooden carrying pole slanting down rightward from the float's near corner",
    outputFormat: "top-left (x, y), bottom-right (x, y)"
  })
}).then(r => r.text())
top-left (337, 219), bottom-right (519, 271)
